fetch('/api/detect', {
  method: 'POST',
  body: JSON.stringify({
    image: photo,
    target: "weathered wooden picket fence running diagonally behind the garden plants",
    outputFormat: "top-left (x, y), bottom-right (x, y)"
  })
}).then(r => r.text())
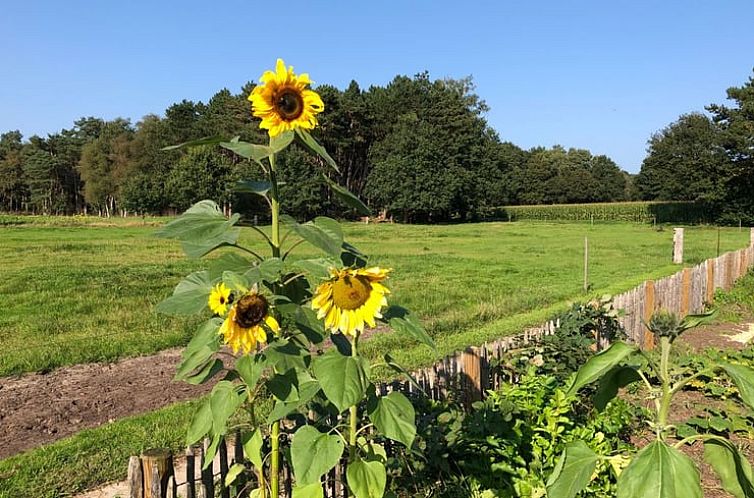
top-left (129, 234), bottom-right (754, 498)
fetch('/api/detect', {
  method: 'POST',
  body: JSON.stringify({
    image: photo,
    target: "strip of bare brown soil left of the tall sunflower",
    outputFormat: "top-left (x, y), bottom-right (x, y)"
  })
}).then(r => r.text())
top-left (0, 349), bottom-right (211, 459)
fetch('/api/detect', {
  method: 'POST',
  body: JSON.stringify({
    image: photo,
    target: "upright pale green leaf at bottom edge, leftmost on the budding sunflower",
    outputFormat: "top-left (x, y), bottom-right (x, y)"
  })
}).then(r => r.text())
top-left (547, 441), bottom-right (598, 498)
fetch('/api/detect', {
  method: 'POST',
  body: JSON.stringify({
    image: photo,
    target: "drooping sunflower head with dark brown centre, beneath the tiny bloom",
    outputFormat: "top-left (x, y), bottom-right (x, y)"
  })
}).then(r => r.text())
top-left (219, 291), bottom-right (280, 353)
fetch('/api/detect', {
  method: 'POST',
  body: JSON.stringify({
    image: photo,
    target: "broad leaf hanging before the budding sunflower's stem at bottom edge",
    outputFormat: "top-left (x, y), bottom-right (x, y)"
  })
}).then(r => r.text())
top-left (617, 441), bottom-right (702, 498)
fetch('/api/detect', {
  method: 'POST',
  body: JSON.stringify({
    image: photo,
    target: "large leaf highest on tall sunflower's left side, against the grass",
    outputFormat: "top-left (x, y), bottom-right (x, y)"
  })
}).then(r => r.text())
top-left (155, 200), bottom-right (240, 258)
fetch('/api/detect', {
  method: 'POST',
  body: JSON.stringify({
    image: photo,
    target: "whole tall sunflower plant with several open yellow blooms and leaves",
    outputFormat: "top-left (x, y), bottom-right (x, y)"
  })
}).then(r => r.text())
top-left (157, 60), bottom-right (434, 498)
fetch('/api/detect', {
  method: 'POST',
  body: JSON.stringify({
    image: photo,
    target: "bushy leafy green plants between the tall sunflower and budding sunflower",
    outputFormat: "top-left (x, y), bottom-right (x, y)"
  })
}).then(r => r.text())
top-left (391, 367), bottom-right (642, 497)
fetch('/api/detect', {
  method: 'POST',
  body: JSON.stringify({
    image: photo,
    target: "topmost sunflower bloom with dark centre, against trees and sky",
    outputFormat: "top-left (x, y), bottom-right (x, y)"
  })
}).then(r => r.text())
top-left (249, 59), bottom-right (325, 137)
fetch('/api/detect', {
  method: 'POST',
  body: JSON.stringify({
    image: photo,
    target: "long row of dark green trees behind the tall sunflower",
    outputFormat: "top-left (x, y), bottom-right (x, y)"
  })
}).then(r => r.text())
top-left (0, 72), bottom-right (634, 222)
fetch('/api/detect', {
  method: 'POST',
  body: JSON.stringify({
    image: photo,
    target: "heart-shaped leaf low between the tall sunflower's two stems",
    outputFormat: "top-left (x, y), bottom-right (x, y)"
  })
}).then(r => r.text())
top-left (291, 425), bottom-right (343, 485)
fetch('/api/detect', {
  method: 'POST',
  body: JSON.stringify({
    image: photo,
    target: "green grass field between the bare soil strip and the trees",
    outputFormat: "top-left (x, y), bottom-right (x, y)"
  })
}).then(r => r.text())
top-left (0, 218), bottom-right (749, 376)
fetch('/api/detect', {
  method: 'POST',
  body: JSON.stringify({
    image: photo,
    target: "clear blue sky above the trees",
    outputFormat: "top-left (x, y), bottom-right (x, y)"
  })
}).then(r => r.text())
top-left (0, 0), bottom-right (754, 172)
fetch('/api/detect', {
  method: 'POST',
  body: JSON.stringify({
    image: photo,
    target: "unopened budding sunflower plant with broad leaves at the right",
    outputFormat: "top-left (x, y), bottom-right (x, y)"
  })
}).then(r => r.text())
top-left (550, 312), bottom-right (754, 498)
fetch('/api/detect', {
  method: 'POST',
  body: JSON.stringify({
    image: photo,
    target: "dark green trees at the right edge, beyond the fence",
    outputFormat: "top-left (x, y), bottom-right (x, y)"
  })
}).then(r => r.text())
top-left (636, 69), bottom-right (754, 225)
